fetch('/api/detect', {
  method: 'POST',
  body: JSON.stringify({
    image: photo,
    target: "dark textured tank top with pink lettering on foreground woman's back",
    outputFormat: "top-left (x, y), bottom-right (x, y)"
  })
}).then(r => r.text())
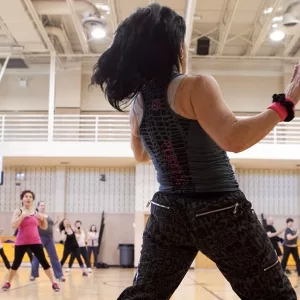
top-left (139, 74), bottom-right (239, 193)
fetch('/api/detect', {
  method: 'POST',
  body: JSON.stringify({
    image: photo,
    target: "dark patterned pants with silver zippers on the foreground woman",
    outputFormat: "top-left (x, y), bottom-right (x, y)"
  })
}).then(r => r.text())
top-left (118, 191), bottom-right (297, 300)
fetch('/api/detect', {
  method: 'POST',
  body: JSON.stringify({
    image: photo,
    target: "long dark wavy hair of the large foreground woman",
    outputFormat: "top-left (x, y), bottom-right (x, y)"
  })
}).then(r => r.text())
top-left (91, 3), bottom-right (186, 111)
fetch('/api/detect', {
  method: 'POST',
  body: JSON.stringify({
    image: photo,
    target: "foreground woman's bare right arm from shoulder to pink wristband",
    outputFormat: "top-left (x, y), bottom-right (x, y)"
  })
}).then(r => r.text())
top-left (175, 76), bottom-right (280, 153)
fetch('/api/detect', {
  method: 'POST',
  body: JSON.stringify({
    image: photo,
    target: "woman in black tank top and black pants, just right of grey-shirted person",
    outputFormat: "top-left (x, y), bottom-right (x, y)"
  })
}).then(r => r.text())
top-left (59, 219), bottom-right (88, 276)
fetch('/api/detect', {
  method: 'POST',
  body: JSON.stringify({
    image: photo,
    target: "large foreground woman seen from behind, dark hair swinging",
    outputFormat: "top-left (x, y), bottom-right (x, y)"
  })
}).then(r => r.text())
top-left (91, 3), bottom-right (300, 300)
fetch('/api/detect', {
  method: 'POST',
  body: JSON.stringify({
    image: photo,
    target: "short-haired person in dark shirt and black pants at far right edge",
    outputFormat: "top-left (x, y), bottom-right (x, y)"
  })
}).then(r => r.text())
top-left (281, 218), bottom-right (300, 276)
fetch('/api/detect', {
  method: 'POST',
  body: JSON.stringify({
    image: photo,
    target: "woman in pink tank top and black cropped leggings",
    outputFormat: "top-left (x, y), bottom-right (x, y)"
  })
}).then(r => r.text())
top-left (2, 190), bottom-right (59, 292)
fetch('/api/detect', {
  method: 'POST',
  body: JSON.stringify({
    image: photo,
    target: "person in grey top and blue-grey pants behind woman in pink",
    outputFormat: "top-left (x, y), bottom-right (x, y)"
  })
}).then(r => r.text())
top-left (30, 201), bottom-right (66, 282)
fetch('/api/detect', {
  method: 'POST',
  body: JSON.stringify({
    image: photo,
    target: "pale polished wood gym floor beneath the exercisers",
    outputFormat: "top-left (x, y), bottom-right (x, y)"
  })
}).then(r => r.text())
top-left (0, 267), bottom-right (300, 300)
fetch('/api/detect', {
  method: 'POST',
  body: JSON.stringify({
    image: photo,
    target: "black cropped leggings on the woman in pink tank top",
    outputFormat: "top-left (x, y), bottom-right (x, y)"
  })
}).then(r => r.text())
top-left (11, 244), bottom-right (50, 271)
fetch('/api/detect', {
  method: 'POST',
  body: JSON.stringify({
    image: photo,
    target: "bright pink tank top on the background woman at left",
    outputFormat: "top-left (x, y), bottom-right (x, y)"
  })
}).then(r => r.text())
top-left (15, 211), bottom-right (42, 246)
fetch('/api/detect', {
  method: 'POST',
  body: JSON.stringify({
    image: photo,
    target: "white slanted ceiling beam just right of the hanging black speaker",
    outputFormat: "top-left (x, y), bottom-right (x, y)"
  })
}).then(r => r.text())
top-left (216, 0), bottom-right (240, 55)
